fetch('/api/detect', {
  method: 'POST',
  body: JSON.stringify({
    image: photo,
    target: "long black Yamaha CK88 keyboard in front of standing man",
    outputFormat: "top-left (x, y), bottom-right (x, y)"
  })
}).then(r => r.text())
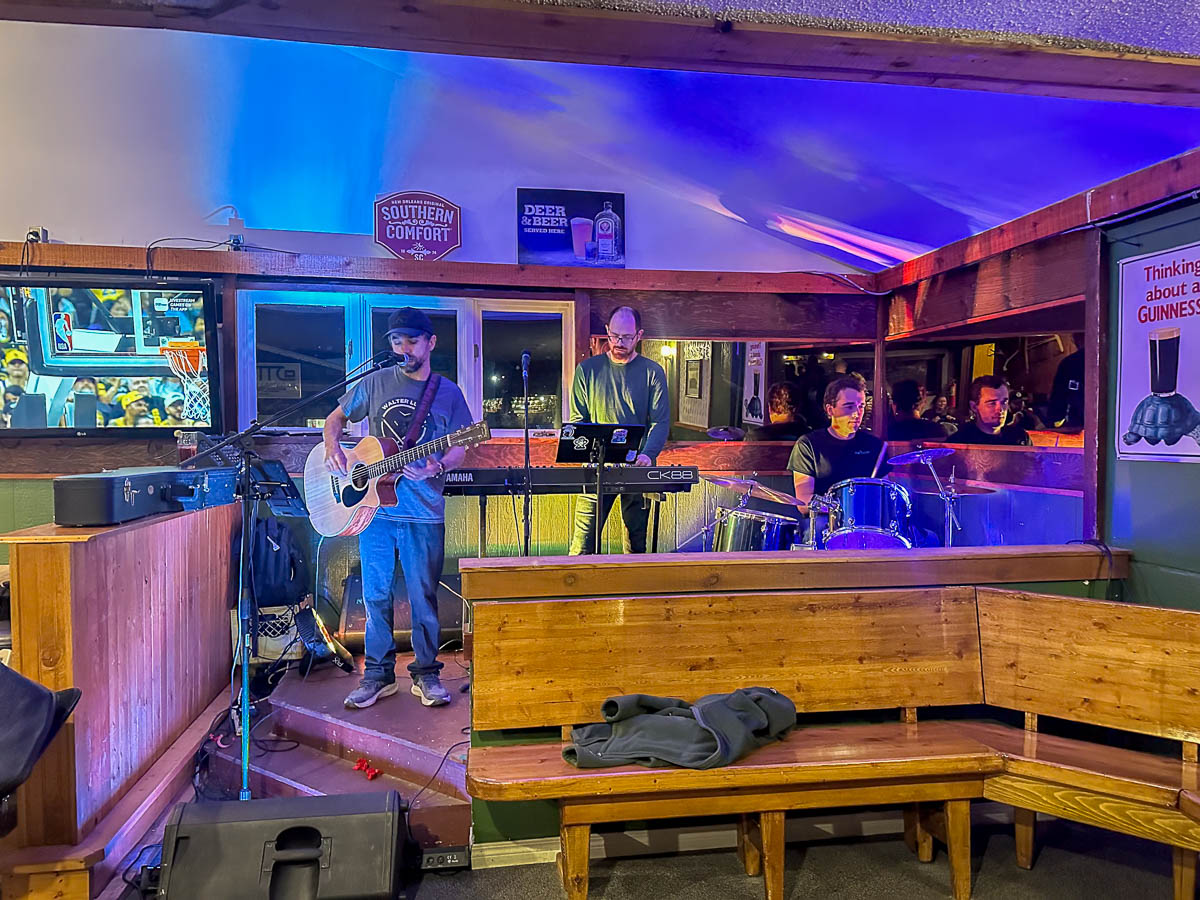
top-left (445, 466), bottom-right (700, 497)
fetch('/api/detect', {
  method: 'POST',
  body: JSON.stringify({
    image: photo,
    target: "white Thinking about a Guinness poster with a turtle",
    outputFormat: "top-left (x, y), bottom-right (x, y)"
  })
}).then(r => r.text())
top-left (1113, 244), bottom-right (1200, 462)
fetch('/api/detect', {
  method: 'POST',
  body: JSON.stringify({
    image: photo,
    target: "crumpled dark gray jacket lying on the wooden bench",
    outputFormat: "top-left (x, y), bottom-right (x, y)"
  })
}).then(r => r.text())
top-left (563, 688), bottom-right (796, 769)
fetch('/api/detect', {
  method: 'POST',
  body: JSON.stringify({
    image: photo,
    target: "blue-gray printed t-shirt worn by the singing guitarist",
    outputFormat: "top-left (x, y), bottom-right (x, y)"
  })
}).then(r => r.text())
top-left (338, 368), bottom-right (470, 522)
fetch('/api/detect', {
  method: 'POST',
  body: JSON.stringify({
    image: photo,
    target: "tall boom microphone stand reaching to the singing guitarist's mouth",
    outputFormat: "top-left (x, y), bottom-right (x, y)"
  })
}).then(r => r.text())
top-left (180, 350), bottom-right (397, 800)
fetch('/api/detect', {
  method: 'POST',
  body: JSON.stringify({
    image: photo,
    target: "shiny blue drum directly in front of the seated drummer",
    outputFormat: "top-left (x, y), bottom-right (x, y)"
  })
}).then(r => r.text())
top-left (824, 478), bottom-right (912, 550)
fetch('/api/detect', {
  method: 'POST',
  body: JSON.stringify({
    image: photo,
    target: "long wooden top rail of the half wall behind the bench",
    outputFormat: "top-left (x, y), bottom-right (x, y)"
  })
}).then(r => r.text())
top-left (458, 544), bottom-right (1130, 601)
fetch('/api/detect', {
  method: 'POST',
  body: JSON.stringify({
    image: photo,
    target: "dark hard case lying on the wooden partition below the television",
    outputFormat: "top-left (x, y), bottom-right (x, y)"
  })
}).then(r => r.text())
top-left (54, 466), bottom-right (238, 526)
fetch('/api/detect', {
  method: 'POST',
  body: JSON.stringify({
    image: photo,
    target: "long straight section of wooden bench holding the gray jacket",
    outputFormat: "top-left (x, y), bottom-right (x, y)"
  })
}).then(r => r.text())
top-left (467, 588), bottom-right (1001, 900)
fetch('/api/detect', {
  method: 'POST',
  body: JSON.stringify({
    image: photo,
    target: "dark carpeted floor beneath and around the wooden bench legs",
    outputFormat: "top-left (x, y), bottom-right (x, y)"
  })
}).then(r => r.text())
top-left (408, 821), bottom-right (1171, 900)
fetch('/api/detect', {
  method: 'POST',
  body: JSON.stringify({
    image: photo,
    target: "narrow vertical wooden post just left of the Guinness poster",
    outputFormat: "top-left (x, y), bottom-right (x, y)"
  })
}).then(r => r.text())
top-left (1084, 230), bottom-right (1112, 540)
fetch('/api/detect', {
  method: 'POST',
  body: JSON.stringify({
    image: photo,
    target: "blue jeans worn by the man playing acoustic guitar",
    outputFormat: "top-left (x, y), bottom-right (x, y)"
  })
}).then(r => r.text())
top-left (359, 515), bottom-right (445, 684)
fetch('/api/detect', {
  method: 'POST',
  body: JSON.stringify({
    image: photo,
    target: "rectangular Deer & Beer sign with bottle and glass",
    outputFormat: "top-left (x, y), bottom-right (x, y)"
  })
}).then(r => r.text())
top-left (517, 187), bottom-right (625, 269)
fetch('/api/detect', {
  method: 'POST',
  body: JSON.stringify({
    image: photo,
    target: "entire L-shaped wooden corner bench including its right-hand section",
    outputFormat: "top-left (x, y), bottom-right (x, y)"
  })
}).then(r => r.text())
top-left (464, 551), bottom-right (1200, 900)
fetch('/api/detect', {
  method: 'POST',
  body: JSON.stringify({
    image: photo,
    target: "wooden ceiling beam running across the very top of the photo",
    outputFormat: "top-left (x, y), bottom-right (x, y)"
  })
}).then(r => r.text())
top-left (7, 0), bottom-right (1200, 107)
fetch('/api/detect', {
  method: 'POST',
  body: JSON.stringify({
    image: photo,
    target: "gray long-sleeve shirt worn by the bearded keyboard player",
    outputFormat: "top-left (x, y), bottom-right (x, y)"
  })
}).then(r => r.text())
top-left (571, 353), bottom-right (671, 461)
